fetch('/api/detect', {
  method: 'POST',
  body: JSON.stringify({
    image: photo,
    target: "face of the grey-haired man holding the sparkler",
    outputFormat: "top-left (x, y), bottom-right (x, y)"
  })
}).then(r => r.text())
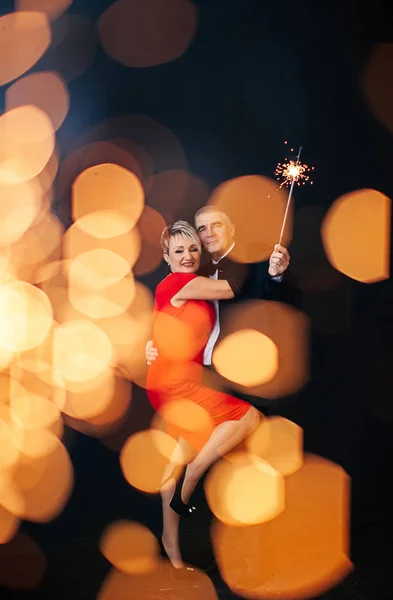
top-left (195, 210), bottom-right (235, 260)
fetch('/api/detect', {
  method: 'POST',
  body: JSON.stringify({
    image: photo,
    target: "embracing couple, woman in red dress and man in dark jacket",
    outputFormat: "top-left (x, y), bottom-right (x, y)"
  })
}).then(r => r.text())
top-left (146, 206), bottom-right (289, 569)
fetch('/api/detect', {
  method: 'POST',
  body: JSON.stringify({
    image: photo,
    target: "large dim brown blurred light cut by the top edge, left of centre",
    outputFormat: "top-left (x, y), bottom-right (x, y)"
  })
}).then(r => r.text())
top-left (98, 0), bottom-right (198, 67)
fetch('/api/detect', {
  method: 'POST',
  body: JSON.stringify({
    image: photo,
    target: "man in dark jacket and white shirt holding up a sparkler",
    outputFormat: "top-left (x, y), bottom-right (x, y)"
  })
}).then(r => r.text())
top-left (146, 206), bottom-right (290, 366)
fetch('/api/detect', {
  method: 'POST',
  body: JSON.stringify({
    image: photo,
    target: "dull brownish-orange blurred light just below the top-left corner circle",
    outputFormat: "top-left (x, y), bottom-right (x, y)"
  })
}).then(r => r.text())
top-left (5, 73), bottom-right (70, 131)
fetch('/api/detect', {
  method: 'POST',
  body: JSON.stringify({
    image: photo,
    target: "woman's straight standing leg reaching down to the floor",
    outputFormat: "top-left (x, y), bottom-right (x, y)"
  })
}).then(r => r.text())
top-left (160, 438), bottom-right (187, 569)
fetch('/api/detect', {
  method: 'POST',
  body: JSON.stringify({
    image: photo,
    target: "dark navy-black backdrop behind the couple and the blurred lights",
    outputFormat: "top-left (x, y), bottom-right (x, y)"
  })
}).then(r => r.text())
top-left (0, 0), bottom-right (393, 600)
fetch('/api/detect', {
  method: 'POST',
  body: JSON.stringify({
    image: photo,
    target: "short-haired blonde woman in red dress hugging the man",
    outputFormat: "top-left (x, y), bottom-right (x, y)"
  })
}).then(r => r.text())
top-left (147, 221), bottom-right (259, 568)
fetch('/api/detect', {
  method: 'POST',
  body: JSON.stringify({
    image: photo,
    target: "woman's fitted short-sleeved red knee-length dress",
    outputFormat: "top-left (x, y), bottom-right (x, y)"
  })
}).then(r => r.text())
top-left (146, 273), bottom-right (250, 438)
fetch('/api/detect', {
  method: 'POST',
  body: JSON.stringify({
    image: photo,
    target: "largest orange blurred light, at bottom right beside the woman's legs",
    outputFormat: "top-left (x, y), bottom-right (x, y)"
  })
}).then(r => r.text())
top-left (212, 455), bottom-right (352, 600)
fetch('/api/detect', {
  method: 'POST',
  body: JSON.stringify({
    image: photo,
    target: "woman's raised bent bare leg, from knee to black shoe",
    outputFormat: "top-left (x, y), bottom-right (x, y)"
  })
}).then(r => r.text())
top-left (181, 406), bottom-right (260, 503)
